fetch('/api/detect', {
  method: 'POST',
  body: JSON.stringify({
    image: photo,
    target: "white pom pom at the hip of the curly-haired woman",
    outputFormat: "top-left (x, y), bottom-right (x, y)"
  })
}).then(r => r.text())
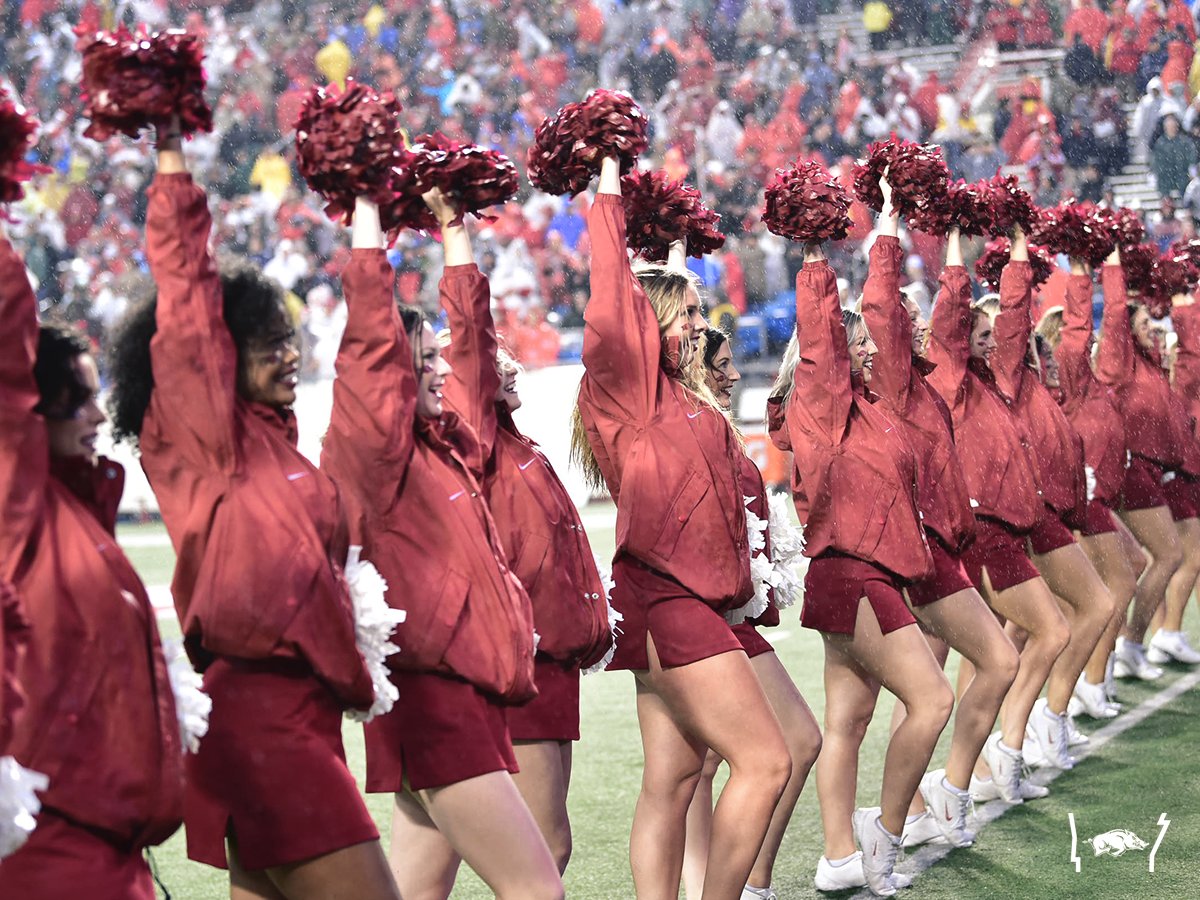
top-left (344, 545), bottom-right (407, 722)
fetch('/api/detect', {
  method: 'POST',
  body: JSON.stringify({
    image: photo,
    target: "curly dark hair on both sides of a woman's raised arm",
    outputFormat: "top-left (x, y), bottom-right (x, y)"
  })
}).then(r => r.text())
top-left (107, 257), bottom-right (287, 445)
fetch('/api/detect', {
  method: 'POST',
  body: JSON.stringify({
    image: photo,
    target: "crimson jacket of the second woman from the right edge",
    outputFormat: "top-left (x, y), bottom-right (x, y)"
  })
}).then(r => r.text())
top-left (1096, 265), bottom-right (1180, 469)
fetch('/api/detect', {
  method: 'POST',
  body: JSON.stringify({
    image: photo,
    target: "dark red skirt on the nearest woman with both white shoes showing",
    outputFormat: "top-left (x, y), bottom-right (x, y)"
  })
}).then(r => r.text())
top-left (800, 553), bottom-right (917, 635)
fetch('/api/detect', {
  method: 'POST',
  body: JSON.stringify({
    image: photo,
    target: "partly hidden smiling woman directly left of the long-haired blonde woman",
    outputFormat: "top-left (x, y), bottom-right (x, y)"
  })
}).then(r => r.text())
top-left (440, 188), bottom-right (612, 872)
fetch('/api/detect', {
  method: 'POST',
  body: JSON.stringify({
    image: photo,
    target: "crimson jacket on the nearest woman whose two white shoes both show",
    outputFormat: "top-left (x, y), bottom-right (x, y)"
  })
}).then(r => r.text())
top-left (770, 256), bottom-right (932, 580)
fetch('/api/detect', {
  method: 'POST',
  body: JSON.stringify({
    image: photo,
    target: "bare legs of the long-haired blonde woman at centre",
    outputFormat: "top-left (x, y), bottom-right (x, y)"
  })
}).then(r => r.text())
top-left (629, 636), bottom-right (791, 900)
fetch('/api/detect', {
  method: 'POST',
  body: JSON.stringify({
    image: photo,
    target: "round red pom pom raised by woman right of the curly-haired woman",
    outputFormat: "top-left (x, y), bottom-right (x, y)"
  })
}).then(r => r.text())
top-left (295, 79), bottom-right (403, 222)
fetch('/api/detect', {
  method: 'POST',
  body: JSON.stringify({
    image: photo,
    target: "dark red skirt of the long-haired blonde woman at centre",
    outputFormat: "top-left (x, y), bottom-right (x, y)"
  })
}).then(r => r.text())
top-left (607, 556), bottom-right (742, 672)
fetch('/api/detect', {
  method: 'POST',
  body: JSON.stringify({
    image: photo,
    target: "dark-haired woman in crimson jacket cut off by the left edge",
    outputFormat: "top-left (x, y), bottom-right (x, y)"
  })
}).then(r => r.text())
top-left (0, 229), bottom-right (184, 900)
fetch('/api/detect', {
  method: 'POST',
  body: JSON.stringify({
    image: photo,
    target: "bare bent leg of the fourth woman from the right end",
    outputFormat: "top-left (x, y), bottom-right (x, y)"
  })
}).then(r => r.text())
top-left (1033, 544), bottom-right (1116, 715)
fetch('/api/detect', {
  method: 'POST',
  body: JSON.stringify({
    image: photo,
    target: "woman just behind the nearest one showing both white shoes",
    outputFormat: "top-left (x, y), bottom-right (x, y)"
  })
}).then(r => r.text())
top-left (863, 179), bottom-right (1018, 847)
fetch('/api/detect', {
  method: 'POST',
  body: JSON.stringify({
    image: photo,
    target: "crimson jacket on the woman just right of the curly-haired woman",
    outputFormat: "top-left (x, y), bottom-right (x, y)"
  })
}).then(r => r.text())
top-left (322, 250), bottom-right (536, 705)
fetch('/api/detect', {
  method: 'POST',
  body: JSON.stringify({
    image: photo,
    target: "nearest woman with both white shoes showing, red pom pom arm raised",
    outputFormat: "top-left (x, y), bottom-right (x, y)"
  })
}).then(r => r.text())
top-left (769, 237), bottom-right (954, 896)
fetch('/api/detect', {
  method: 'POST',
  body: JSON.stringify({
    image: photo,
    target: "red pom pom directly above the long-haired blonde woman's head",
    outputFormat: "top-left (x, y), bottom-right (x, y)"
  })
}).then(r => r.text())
top-left (620, 170), bottom-right (725, 262)
